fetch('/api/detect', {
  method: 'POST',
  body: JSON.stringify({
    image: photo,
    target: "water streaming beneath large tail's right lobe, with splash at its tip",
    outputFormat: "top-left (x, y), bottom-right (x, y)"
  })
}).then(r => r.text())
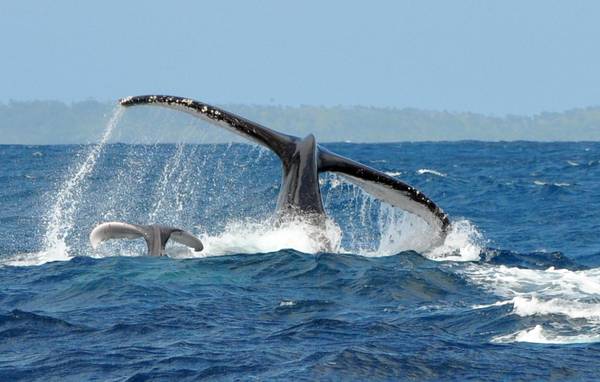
top-left (321, 174), bottom-right (483, 261)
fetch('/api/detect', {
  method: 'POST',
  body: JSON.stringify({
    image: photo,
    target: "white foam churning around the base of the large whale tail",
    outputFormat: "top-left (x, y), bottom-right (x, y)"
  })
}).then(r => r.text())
top-left (167, 206), bottom-right (483, 261)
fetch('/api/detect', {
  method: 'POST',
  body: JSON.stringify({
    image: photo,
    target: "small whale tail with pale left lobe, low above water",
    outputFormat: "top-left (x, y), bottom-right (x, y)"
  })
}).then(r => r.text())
top-left (90, 222), bottom-right (204, 256)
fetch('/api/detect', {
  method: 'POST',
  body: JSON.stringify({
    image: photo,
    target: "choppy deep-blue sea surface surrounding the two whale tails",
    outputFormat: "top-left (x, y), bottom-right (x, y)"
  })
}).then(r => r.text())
top-left (0, 112), bottom-right (600, 381)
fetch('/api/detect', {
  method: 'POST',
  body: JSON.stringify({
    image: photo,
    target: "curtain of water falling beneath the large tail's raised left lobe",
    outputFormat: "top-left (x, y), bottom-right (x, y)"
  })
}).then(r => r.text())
top-left (36, 108), bottom-right (280, 262)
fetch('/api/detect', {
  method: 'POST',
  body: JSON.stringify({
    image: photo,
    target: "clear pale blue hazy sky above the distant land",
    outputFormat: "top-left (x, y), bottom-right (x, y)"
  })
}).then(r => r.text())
top-left (0, 0), bottom-right (600, 114)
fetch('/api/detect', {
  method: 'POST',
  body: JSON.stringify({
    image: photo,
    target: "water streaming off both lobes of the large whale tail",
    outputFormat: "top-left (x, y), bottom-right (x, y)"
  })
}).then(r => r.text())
top-left (17, 104), bottom-right (478, 262)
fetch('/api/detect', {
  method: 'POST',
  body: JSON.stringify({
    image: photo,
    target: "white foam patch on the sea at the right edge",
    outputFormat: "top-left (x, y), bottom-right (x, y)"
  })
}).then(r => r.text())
top-left (465, 264), bottom-right (600, 344)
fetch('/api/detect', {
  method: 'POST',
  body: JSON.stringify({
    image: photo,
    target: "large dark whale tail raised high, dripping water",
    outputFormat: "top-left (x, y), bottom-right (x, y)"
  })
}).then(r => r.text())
top-left (119, 95), bottom-right (450, 242)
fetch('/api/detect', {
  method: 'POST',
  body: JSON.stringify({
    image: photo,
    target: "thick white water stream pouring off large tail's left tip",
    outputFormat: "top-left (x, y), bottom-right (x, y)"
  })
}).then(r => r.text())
top-left (36, 107), bottom-right (123, 264)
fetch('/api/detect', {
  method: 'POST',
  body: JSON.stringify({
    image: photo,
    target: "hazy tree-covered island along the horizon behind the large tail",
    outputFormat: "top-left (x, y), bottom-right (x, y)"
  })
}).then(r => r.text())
top-left (0, 100), bottom-right (600, 145)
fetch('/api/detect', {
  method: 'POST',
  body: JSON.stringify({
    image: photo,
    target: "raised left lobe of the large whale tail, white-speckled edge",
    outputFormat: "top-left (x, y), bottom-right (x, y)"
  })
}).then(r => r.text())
top-left (119, 95), bottom-right (298, 164)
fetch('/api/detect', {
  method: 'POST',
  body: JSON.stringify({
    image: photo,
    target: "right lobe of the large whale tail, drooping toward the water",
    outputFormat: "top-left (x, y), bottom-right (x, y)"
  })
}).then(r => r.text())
top-left (319, 147), bottom-right (450, 237)
